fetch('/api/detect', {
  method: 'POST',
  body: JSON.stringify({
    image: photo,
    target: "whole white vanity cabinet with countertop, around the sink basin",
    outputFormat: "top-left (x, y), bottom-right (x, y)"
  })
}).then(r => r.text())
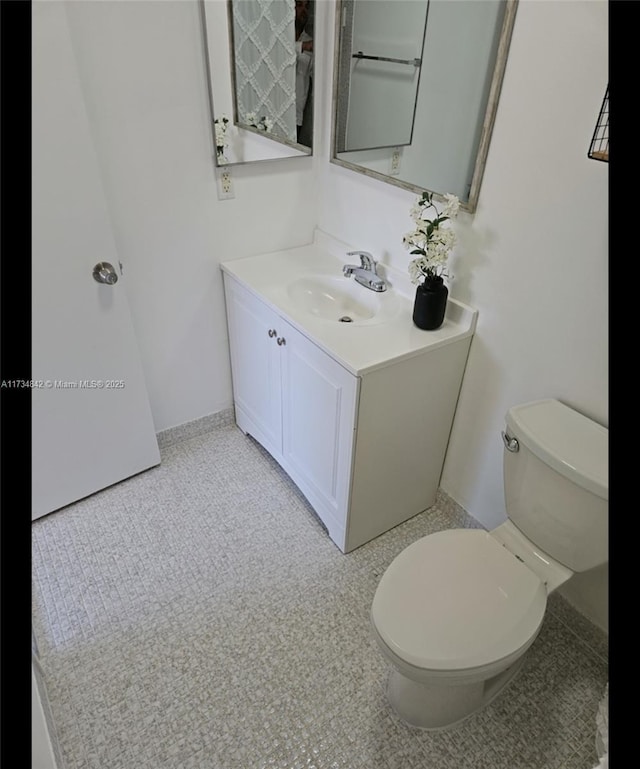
top-left (222, 240), bottom-right (477, 553)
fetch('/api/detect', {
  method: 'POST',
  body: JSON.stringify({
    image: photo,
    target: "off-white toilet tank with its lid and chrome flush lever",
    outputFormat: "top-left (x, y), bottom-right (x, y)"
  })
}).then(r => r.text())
top-left (503, 399), bottom-right (609, 572)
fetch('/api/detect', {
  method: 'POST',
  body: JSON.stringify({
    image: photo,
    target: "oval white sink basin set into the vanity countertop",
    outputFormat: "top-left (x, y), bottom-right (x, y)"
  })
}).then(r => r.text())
top-left (287, 275), bottom-right (400, 325)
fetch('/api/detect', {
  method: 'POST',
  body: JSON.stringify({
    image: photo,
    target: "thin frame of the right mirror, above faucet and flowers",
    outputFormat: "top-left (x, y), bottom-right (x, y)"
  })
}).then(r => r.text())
top-left (329, 0), bottom-right (519, 213)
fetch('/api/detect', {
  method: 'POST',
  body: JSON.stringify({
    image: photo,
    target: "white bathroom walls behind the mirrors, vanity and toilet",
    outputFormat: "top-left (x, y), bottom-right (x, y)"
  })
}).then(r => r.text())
top-left (60, 0), bottom-right (608, 626)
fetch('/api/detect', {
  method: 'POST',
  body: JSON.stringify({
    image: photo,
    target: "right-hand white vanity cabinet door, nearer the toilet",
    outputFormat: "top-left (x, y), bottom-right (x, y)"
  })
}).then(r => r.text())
top-left (282, 326), bottom-right (359, 547)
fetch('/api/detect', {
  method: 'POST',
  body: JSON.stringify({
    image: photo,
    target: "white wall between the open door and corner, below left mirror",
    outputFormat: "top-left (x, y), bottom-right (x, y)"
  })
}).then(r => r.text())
top-left (69, 0), bottom-right (317, 431)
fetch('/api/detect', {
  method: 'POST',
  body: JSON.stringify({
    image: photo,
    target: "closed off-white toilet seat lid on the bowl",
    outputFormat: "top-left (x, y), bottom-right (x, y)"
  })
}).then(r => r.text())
top-left (371, 529), bottom-right (547, 672)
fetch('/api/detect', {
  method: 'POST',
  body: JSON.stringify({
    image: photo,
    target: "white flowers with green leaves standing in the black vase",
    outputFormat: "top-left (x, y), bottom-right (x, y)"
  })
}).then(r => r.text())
top-left (402, 192), bottom-right (460, 284)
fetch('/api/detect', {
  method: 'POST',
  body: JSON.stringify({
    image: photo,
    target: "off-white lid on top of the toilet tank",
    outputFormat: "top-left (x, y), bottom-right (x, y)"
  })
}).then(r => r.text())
top-left (506, 398), bottom-right (609, 499)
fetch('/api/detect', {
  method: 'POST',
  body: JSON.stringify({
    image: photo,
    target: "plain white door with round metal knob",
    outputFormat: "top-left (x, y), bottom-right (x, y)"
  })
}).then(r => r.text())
top-left (32, 0), bottom-right (160, 520)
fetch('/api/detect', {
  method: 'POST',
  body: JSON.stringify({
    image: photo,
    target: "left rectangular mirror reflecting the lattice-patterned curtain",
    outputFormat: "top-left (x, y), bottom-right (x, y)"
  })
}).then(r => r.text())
top-left (200, 0), bottom-right (314, 166)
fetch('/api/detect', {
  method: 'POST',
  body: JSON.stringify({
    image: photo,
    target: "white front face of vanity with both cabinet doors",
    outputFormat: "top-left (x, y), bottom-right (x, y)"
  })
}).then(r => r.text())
top-left (224, 275), bottom-right (360, 546)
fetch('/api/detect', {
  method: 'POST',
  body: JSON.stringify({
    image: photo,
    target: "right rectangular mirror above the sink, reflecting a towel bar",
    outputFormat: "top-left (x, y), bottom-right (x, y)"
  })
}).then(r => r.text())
top-left (331, 0), bottom-right (517, 211)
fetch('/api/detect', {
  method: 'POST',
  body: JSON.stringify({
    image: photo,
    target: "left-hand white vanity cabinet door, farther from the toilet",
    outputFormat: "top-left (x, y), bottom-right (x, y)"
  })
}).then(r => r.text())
top-left (224, 275), bottom-right (283, 452)
